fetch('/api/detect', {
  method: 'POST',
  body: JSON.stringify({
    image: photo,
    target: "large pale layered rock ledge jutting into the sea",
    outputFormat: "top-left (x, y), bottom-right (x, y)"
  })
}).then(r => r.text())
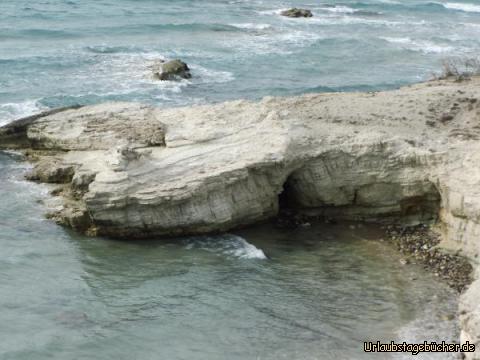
top-left (0, 78), bottom-right (480, 358)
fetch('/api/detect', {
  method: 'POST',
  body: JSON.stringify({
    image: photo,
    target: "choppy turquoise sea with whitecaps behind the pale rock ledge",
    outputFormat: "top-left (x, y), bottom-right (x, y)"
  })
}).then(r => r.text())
top-left (0, 0), bottom-right (480, 123)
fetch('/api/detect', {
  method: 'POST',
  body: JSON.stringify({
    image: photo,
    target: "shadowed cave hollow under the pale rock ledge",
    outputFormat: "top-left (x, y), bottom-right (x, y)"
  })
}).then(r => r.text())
top-left (278, 171), bottom-right (441, 226)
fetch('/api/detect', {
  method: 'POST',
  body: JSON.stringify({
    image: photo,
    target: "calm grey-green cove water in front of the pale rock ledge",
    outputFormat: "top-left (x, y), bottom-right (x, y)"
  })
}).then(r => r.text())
top-left (0, 152), bottom-right (458, 360)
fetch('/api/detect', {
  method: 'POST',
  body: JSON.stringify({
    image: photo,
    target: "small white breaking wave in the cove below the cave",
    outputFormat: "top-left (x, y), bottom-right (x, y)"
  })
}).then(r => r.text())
top-left (185, 234), bottom-right (267, 260)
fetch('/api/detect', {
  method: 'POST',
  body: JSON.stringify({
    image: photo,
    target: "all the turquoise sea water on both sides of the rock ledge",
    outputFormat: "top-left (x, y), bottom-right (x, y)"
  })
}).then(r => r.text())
top-left (0, 0), bottom-right (480, 360)
